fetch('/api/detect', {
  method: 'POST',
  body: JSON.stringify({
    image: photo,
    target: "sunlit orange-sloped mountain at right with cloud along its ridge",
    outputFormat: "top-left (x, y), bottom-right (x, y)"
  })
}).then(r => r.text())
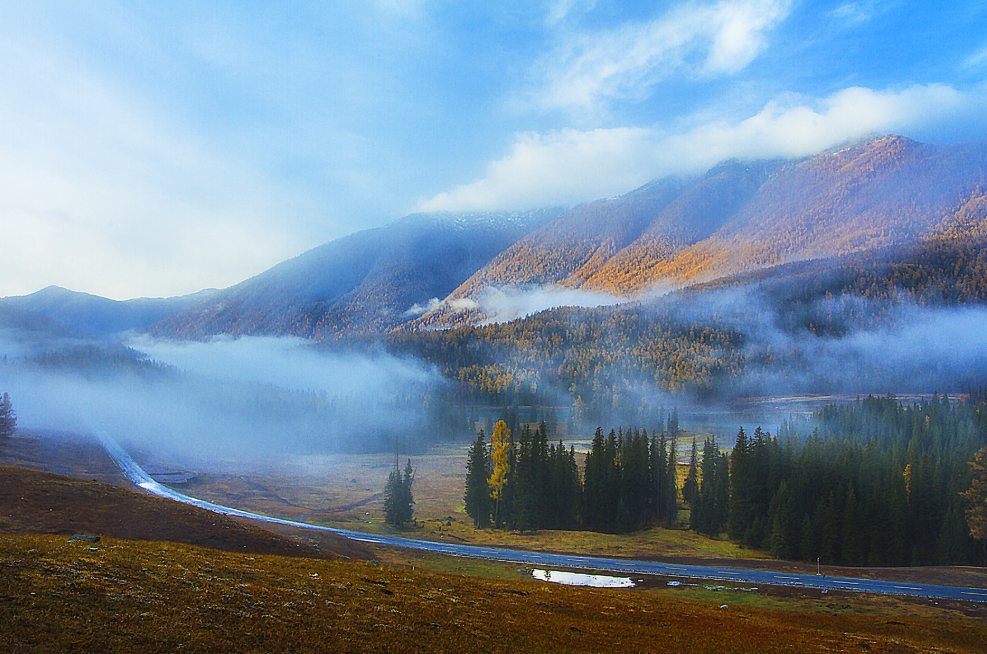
top-left (416, 136), bottom-right (987, 326)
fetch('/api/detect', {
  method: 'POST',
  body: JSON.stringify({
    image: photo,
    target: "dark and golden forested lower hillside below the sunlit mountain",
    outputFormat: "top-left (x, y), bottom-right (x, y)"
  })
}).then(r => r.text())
top-left (384, 233), bottom-right (987, 424)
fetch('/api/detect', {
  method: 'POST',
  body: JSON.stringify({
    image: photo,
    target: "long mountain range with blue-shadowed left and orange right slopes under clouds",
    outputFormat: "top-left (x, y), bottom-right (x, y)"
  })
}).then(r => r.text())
top-left (149, 136), bottom-right (987, 339)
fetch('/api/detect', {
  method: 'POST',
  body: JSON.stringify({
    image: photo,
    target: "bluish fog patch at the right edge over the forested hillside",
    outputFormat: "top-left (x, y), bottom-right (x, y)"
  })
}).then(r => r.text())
top-left (711, 291), bottom-right (987, 395)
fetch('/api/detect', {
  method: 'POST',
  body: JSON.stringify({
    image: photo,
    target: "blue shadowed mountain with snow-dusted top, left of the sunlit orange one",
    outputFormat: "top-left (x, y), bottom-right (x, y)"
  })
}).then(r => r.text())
top-left (149, 209), bottom-right (562, 339)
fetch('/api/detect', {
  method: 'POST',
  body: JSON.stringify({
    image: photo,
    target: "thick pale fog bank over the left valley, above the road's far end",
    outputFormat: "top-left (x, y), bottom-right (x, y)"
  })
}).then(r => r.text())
top-left (0, 338), bottom-right (448, 469)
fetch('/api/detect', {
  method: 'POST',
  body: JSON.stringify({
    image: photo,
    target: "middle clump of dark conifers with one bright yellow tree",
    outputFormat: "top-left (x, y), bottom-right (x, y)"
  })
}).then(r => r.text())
top-left (463, 418), bottom-right (678, 533)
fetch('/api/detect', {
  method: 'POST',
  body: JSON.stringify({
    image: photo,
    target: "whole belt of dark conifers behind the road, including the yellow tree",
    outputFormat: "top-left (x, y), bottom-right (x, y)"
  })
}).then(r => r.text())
top-left (465, 391), bottom-right (987, 566)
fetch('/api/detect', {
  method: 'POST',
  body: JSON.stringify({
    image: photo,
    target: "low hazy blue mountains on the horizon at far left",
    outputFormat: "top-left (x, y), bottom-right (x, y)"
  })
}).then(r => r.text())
top-left (0, 286), bottom-right (215, 338)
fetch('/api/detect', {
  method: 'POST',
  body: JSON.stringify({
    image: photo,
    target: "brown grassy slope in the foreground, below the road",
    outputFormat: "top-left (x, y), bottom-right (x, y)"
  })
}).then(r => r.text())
top-left (0, 536), bottom-right (987, 653)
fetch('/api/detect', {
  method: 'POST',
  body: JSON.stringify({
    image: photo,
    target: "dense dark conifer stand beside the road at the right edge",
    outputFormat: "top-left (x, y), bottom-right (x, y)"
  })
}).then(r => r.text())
top-left (725, 393), bottom-right (987, 566)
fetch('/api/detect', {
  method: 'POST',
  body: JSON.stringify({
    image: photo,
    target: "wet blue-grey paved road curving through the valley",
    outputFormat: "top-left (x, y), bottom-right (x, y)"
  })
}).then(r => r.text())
top-left (93, 428), bottom-right (987, 602)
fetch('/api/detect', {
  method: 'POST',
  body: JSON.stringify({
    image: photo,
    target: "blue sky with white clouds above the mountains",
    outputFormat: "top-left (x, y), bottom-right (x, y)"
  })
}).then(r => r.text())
top-left (0, 0), bottom-right (987, 299)
